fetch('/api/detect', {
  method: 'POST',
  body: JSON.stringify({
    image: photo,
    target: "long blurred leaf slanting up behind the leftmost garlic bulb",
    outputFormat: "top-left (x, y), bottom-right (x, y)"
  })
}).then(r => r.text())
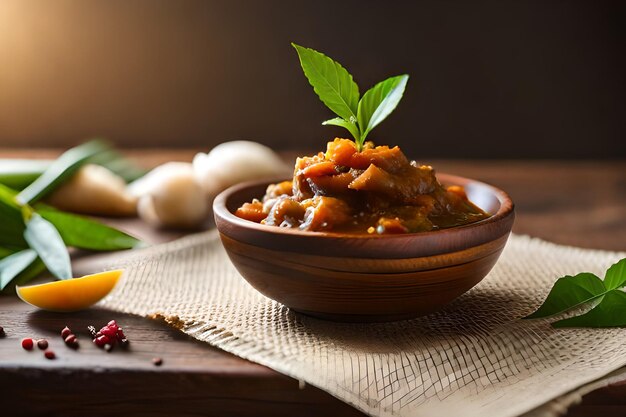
top-left (17, 140), bottom-right (110, 204)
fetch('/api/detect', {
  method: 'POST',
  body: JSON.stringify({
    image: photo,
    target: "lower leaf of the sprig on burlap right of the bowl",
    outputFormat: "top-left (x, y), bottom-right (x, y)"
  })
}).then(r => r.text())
top-left (552, 290), bottom-right (626, 327)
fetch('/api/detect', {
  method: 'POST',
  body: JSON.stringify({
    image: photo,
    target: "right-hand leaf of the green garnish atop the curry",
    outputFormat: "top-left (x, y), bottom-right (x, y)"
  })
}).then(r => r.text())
top-left (357, 75), bottom-right (409, 142)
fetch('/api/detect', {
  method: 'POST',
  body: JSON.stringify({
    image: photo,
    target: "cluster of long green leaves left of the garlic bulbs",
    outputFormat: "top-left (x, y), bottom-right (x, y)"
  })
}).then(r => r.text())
top-left (0, 141), bottom-right (141, 291)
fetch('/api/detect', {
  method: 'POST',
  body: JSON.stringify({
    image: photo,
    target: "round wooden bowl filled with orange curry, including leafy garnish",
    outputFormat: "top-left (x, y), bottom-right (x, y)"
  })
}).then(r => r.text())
top-left (213, 45), bottom-right (515, 322)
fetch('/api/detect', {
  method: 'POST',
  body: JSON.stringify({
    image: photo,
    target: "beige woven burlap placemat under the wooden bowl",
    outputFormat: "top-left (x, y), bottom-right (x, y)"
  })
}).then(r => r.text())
top-left (88, 232), bottom-right (626, 417)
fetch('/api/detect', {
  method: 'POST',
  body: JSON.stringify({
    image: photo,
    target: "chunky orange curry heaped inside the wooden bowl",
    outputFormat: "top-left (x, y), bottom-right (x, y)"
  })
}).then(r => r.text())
top-left (235, 139), bottom-right (489, 234)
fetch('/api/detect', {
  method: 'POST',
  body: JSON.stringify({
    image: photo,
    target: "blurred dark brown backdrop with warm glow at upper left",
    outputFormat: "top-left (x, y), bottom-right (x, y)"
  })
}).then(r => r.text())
top-left (0, 0), bottom-right (626, 158)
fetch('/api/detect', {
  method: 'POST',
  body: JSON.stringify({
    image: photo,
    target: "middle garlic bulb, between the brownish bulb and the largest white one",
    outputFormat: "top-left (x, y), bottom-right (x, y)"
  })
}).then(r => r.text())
top-left (129, 162), bottom-right (209, 228)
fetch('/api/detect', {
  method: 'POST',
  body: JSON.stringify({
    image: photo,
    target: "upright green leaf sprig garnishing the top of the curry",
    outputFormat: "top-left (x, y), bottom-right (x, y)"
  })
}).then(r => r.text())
top-left (291, 43), bottom-right (409, 151)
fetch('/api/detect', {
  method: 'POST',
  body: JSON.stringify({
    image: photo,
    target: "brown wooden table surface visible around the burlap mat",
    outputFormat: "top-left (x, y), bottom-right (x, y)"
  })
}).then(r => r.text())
top-left (0, 149), bottom-right (626, 417)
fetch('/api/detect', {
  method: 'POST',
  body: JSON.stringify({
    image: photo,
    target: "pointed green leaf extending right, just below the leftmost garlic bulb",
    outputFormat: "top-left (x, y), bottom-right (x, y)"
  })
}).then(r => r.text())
top-left (36, 205), bottom-right (141, 251)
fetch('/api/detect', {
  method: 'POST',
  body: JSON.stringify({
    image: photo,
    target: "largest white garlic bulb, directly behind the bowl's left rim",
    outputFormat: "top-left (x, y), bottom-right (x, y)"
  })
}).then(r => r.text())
top-left (193, 140), bottom-right (292, 199)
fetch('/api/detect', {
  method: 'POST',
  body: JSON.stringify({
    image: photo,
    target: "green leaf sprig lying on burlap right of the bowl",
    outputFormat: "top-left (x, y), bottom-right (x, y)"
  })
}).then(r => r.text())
top-left (525, 258), bottom-right (626, 327)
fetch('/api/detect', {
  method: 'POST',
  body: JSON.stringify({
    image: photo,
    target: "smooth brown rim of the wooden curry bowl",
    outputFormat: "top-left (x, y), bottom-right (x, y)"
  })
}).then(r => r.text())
top-left (213, 173), bottom-right (515, 240)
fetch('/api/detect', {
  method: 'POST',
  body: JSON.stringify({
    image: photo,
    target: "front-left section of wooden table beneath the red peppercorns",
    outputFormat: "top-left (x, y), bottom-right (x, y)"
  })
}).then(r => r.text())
top-left (0, 297), bottom-right (361, 417)
